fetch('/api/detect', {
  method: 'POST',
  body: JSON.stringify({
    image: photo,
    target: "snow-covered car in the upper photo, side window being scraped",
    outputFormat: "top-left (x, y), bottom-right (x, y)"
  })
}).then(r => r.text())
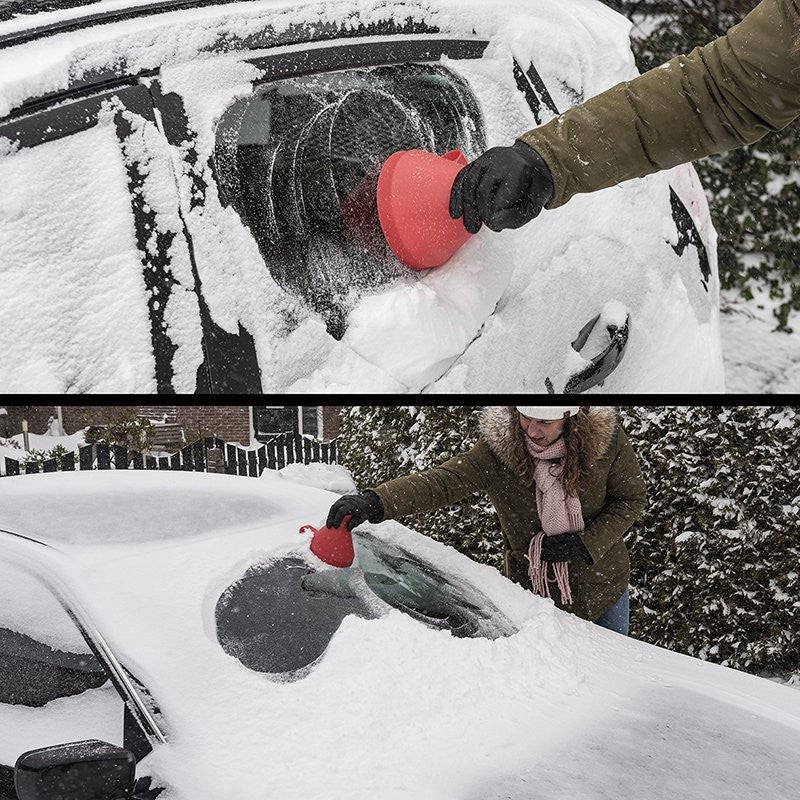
top-left (0, 0), bottom-right (723, 392)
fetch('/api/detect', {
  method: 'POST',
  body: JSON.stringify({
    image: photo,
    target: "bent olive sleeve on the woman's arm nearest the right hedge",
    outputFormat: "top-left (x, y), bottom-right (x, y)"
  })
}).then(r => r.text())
top-left (581, 427), bottom-right (647, 563)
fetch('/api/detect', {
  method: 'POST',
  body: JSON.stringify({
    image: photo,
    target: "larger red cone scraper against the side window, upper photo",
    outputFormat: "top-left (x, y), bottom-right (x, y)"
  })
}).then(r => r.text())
top-left (378, 150), bottom-right (472, 269)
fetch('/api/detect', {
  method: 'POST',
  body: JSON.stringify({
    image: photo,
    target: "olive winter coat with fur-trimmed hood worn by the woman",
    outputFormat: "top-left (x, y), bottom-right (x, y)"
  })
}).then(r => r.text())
top-left (372, 407), bottom-right (645, 620)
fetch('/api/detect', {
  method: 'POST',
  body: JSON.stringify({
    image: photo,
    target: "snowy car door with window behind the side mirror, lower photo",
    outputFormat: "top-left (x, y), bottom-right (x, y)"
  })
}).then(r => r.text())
top-left (0, 530), bottom-right (165, 800)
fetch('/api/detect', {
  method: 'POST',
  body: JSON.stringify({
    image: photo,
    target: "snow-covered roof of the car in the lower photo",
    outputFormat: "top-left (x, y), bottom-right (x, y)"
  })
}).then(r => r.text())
top-left (0, 470), bottom-right (335, 548)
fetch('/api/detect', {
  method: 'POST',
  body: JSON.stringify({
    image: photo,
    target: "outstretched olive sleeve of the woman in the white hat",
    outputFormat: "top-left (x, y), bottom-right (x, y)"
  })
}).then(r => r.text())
top-left (371, 441), bottom-right (492, 519)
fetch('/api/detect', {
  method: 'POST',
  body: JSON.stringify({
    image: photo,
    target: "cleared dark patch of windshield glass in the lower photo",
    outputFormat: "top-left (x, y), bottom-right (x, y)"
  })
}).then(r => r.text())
top-left (215, 533), bottom-right (516, 680)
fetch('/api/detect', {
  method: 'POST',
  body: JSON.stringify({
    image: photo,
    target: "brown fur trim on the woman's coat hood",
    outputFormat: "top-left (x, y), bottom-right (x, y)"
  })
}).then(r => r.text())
top-left (479, 406), bottom-right (619, 486)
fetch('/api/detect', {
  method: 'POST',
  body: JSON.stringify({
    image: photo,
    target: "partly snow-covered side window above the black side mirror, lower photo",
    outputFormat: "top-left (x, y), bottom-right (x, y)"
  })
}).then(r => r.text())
top-left (0, 560), bottom-right (124, 768)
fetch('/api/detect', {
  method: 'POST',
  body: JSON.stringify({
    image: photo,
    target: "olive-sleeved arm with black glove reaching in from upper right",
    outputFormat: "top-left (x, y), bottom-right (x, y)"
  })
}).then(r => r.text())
top-left (450, 0), bottom-right (800, 233)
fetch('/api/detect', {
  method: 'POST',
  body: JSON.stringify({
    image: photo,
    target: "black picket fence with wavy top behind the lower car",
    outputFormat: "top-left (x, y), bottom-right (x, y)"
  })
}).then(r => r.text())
top-left (0, 434), bottom-right (337, 478)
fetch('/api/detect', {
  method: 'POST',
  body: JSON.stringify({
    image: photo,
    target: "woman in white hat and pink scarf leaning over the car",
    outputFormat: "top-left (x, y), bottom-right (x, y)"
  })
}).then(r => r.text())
top-left (327, 406), bottom-right (645, 634)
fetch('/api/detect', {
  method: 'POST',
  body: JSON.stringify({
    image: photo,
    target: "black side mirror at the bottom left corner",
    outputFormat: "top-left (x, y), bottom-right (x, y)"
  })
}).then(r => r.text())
top-left (14, 739), bottom-right (136, 800)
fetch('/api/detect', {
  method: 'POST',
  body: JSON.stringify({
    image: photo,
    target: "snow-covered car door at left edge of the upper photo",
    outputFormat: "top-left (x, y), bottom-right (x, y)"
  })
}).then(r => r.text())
top-left (0, 73), bottom-right (203, 393)
